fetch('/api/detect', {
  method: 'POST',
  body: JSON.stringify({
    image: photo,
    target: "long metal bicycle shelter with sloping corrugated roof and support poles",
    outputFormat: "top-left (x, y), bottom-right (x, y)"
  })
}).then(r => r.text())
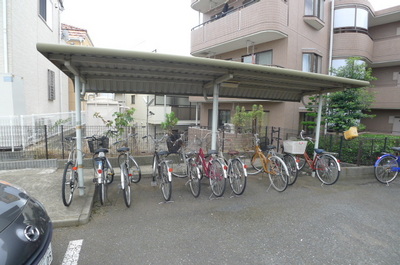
top-left (36, 43), bottom-right (369, 195)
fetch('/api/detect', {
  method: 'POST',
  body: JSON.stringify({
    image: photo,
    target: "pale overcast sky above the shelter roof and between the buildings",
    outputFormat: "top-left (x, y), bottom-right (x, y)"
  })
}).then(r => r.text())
top-left (61, 0), bottom-right (400, 55)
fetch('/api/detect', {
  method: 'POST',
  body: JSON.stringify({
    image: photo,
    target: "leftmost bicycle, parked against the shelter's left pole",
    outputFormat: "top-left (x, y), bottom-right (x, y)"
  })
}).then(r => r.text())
top-left (61, 136), bottom-right (85, 207)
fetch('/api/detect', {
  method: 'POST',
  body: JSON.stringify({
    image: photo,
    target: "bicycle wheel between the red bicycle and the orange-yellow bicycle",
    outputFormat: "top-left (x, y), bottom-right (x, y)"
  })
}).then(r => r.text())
top-left (228, 158), bottom-right (247, 195)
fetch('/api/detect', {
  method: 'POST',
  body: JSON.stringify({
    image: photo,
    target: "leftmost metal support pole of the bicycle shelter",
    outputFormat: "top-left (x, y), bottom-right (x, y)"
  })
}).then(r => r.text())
top-left (75, 75), bottom-right (85, 196)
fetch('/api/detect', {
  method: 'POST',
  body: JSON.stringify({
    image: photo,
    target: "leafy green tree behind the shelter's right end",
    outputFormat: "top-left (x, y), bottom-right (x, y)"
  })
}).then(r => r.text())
top-left (325, 57), bottom-right (376, 132)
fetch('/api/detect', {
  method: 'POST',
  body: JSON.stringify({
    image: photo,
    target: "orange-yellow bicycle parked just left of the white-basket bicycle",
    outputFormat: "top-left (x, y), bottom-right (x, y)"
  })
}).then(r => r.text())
top-left (247, 134), bottom-right (289, 192)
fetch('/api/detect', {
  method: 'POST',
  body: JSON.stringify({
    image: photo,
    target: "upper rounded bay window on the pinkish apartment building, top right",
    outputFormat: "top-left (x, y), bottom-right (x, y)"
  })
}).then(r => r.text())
top-left (333, 6), bottom-right (368, 34)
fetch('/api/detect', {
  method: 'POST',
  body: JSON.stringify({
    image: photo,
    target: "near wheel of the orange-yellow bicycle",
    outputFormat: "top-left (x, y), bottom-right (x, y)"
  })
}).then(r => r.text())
top-left (268, 156), bottom-right (289, 192)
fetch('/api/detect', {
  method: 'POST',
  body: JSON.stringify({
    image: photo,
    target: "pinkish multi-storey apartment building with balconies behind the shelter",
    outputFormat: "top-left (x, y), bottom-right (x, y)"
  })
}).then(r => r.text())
top-left (191, 0), bottom-right (400, 133)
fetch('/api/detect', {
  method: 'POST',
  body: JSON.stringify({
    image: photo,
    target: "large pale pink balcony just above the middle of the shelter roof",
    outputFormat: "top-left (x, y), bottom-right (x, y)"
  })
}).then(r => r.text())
top-left (191, 0), bottom-right (288, 57)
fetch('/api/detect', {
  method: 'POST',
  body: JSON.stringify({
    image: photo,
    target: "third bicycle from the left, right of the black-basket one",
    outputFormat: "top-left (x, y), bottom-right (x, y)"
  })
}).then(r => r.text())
top-left (114, 134), bottom-right (142, 207)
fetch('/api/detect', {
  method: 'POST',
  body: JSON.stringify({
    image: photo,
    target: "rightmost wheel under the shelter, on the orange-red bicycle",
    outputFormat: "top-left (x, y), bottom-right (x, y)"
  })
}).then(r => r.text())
top-left (315, 154), bottom-right (340, 185)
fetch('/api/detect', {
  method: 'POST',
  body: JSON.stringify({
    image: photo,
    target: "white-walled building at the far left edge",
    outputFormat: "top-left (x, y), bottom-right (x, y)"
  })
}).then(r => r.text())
top-left (0, 0), bottom-right (68, 117)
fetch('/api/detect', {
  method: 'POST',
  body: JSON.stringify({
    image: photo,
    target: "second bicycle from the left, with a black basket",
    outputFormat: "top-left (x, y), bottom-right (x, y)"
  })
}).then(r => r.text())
top-left (88, 131), bottom-right (115, 205)
